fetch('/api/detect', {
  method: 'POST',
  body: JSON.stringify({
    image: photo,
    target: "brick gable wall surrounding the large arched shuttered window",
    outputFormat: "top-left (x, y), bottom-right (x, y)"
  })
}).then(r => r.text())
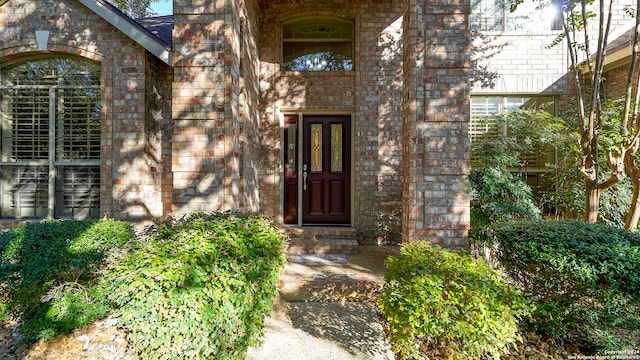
top-left (0, 0), bottom-right (171, 225)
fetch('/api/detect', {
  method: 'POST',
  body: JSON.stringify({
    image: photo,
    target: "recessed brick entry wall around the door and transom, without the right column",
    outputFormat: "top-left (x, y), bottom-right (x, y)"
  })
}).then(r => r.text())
top-left (259, 0), bottom-right (405, 240)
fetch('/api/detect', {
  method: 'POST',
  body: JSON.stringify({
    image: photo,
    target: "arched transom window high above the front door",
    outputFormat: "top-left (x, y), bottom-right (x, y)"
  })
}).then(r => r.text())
top-left (281, 17), bottom-right (354, 71)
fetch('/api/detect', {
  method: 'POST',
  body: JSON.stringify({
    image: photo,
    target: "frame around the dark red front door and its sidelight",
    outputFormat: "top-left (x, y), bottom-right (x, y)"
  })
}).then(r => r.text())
top-left (278, 110), bottom-right (356, 227)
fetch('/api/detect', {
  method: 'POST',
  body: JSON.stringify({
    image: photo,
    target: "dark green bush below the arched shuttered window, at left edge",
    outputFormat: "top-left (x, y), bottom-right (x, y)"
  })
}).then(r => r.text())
top-left (0, 220), bottom-right (133, 340)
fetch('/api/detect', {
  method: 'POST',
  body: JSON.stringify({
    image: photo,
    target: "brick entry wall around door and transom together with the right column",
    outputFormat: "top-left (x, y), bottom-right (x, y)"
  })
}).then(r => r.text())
top-left (255, 0), bottom-right (469, 246)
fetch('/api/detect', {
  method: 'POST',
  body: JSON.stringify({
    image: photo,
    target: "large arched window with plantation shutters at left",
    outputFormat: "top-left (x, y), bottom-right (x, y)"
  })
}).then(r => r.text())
top-left (0, 58), bottom-right (100, 218)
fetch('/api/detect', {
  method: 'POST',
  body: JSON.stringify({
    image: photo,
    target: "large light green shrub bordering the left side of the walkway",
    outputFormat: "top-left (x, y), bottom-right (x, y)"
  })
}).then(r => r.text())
top-left (104, 213), bottom-right (286, 359)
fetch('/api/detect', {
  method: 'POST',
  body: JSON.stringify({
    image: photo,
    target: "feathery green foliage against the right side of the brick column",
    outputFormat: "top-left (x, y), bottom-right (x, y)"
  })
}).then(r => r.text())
top-left (469, 109), bottom-right (569, 246)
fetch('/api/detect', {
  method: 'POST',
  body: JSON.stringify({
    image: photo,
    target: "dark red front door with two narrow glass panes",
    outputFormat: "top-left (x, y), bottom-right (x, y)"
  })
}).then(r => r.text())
top-left (300, 116), bottom-right (351, 224)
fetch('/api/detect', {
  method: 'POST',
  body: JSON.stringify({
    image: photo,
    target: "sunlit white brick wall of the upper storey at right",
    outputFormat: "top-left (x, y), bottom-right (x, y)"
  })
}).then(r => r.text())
top-left (471, 2), bottom-right (630, 107)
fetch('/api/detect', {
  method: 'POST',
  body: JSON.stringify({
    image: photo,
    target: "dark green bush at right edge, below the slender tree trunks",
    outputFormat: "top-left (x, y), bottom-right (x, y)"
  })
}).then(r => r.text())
top-left (496, 221), bottom-right (640, 352)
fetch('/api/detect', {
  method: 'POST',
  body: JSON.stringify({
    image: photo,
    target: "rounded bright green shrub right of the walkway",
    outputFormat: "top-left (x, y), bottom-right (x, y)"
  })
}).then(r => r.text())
top-left (378, 242), bottom-right (529, 359)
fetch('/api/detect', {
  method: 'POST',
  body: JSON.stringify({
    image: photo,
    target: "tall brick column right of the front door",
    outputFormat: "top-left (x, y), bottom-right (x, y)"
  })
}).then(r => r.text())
top-left (402, 0), bottom-right (470, 247)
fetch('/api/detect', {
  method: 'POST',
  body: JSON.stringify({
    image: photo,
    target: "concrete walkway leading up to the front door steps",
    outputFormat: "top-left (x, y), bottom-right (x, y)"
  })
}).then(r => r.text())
top-left (246, 246), bottom-right (398, 360)
